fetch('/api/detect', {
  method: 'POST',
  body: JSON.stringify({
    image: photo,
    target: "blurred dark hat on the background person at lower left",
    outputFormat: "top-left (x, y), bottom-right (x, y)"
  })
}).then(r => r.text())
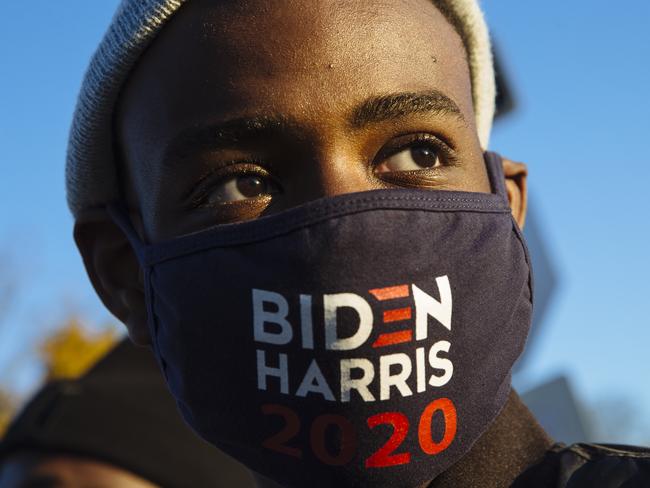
top-left (0, 339), bottom-right (254, 488)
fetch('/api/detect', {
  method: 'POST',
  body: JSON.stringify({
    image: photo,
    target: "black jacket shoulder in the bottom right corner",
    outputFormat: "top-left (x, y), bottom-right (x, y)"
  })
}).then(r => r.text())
top-left (512, 443), bottom-right (650, 488)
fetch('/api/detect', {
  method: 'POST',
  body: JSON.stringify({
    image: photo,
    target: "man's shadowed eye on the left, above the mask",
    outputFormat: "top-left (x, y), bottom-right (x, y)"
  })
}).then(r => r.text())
top-left (193, 164), bottom-right (279, 207)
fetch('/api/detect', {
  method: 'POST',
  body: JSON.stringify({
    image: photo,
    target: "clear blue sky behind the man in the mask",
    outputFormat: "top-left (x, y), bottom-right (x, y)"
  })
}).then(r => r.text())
top-left (0, 0), bottom-right (650, 442)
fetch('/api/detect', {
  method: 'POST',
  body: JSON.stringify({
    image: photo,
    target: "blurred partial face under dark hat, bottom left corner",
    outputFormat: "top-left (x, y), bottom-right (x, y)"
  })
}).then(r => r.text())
top-left (0, 453), bottom-right (156, 488)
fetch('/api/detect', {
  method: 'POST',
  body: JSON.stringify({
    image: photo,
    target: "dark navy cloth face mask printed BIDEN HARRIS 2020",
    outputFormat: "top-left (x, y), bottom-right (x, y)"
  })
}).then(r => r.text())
top-left (110, 153), bottom-right (532, 488)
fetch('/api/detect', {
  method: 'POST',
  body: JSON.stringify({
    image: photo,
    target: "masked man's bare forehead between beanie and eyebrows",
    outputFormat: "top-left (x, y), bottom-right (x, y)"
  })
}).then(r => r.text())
top-left (118, 0), bottom-right (473, 152)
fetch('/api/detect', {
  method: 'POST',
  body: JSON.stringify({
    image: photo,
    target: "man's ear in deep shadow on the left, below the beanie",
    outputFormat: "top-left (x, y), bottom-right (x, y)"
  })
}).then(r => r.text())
top-left (74, 208), bottom-right (151, 345)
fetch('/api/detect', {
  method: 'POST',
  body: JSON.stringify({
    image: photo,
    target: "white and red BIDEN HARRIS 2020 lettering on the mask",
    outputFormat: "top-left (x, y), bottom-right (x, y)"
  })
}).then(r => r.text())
top-left (252, 276), bottom-right (456, 468)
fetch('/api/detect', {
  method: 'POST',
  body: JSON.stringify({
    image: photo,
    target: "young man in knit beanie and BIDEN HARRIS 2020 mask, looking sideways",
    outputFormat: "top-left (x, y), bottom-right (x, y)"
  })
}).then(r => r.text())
top-left (67, 0), bottom-right (648, 488)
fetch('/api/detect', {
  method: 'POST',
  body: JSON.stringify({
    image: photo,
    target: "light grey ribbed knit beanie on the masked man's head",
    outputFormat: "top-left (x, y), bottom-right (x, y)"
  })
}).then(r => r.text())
top-left (66, 0), bottom-right (496, 217)
